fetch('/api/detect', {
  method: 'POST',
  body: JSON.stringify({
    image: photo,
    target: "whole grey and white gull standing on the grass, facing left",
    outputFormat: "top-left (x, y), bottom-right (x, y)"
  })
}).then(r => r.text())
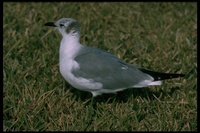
top-left (45, 18), bottom-right (184, 97)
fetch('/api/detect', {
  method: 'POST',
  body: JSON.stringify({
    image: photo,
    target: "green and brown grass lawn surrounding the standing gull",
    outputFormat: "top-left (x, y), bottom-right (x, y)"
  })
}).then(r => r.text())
top-left (3, 2), bottom-right (197, 131)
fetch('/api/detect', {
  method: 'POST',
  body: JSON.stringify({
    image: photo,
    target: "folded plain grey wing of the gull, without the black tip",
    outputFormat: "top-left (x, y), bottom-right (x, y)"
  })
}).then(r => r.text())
top-left (72, 47), bottom-right (151, 89)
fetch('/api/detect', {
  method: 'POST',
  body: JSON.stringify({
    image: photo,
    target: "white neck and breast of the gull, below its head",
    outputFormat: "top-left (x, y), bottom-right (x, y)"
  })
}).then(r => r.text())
top-left (59, 37), bottom-right (103, 91)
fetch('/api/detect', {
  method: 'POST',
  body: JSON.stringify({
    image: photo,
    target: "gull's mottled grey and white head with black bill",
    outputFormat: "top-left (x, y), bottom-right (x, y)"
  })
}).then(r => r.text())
top-left (45, 18), bottom-right (80, 36)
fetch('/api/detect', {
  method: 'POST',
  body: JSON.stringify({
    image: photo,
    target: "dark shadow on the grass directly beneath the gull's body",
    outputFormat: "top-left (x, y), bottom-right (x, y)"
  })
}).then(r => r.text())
top-left (68, 85), bottom-right (180, 103)
